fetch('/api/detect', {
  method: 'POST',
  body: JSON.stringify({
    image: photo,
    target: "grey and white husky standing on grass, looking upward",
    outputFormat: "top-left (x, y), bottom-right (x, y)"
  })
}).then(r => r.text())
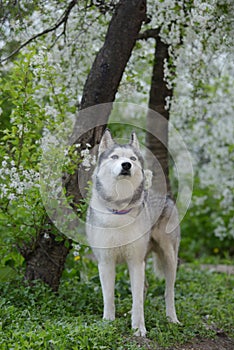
top-left (86, 130), bottom-right (180, 336)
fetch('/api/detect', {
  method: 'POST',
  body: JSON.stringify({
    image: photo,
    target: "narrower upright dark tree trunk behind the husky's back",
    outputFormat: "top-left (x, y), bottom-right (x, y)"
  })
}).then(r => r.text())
top-left (146, 37), bottom-right (172, 194)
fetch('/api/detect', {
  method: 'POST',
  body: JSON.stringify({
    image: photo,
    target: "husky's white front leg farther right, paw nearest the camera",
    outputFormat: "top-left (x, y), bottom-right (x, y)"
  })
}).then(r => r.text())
top-left (128, 260), bottom-right (146, 337)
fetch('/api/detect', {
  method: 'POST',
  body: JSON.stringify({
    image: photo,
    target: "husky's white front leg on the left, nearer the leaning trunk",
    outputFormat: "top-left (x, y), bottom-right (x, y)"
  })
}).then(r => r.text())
top-left (98, 261), bottom-right (115, 320)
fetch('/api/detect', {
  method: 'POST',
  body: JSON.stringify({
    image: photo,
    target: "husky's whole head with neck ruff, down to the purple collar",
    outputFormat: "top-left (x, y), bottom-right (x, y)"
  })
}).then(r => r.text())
top-left (93, 130), bottom-right (151, 211)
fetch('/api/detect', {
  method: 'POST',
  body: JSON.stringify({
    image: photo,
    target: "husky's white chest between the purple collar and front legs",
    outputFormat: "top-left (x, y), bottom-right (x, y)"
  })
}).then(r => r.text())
top-left (87, 207), bottom-right (151, 262)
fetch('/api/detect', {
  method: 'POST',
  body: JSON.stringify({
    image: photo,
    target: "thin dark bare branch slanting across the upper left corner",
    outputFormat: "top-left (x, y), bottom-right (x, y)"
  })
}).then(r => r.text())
top-left (0, 0), bottom-right (78, 63)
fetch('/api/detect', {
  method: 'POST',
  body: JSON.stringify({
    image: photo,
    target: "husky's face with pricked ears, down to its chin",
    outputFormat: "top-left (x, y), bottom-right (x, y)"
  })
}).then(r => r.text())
top-left (98, 129), bottom-right (144, 180)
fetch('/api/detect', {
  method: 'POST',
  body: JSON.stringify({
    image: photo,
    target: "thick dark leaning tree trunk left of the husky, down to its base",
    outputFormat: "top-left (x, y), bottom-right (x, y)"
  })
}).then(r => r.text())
top-left (22, 0), bottom-right (146, 290)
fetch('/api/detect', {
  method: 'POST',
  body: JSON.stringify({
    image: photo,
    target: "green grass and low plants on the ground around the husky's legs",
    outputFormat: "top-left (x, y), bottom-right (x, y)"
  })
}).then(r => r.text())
top-left (0, 254), bottom-right (234, 350)
